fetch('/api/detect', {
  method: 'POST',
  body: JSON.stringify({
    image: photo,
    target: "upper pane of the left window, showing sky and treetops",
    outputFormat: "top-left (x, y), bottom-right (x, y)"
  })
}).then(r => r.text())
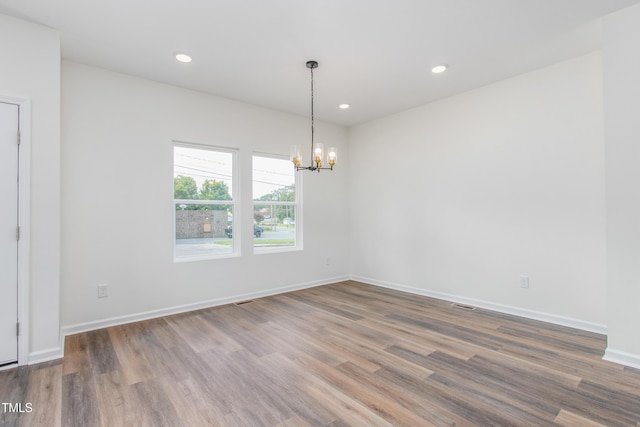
top-left (173, 146), bottom-right (233, 200)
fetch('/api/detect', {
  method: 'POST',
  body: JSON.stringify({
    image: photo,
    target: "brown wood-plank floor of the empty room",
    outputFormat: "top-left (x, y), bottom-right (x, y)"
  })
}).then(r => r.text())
top-left (0, 282), bottom-right (640, 427)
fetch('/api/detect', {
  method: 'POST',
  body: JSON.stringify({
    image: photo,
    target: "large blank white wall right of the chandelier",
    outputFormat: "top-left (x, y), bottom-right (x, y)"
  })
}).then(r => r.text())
top-left (349, 53), bottom-right (607, 331)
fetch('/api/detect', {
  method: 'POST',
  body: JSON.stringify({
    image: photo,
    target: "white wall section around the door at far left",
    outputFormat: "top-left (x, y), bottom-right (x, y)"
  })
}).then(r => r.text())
top-left (0, 15), bottom-right (61, 362)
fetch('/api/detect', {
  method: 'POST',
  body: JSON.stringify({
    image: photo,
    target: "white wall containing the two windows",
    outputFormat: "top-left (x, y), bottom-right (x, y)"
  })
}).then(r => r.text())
top-left (61, 61), bottom-right (349, 332)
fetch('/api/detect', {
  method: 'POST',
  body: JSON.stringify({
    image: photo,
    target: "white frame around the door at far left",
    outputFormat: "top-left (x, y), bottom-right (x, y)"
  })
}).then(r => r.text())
top-left (0, 95), bottom-right (31, 365)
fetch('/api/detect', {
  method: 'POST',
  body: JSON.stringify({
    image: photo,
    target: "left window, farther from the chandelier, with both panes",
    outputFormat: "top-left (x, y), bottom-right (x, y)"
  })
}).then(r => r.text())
top-left (173, 144), bottom-right (237, 261)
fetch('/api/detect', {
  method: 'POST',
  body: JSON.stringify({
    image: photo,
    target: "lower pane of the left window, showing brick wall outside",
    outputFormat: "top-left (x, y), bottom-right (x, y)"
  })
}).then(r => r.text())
top-left (175, 203), bottom-right (233, 258)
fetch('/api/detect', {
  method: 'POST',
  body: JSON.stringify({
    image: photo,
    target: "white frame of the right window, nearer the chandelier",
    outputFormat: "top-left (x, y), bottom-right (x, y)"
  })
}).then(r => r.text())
top-left (251, 151), bottom-right (303, 255)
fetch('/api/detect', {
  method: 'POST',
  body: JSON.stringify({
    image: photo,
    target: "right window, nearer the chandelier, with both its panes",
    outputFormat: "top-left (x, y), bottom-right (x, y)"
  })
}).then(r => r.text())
top-left (253, 154), bottom-right (302, 252)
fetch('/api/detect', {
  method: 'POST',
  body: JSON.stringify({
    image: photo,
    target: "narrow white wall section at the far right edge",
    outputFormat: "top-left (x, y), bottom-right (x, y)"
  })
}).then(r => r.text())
top-left (603, 2), bottom-right (640, 368)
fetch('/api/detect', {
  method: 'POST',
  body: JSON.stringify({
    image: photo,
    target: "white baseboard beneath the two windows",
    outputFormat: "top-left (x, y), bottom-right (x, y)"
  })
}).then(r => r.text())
top-left (62, 276), bottom-right (349, 337)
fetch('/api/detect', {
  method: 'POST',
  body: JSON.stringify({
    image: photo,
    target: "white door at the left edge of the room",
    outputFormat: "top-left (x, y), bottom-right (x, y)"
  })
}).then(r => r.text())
top-left (0, 102), bottom-right (19, 366)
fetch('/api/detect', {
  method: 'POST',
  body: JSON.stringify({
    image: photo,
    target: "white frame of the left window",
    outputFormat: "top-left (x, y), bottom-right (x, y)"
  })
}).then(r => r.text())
top-left (171, 140), bottom-right (242, 263)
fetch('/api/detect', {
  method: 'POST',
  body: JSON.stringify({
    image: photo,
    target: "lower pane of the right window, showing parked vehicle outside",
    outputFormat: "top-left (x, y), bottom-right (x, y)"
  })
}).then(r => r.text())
top-left (253, 204), bottom-right (296, 248)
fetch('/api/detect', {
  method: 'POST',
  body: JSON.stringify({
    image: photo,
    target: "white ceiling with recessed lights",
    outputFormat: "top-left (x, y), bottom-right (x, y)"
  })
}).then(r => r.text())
top-left (0, 0), bottom-right (640, 126)
